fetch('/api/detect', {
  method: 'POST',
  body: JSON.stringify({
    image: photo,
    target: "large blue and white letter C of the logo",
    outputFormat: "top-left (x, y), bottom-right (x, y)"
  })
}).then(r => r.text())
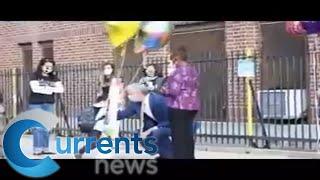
top-left (2, 109), bottom-right (60, 178)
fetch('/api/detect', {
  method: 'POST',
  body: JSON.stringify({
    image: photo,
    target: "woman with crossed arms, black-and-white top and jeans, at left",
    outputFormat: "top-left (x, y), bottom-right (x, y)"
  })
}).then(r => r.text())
top-left (29, 58), bottom-right (64, 155)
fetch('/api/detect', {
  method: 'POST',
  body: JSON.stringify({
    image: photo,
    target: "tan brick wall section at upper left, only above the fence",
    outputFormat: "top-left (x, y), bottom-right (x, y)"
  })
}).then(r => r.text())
top-left (0, 21), bottom-right (113, 69)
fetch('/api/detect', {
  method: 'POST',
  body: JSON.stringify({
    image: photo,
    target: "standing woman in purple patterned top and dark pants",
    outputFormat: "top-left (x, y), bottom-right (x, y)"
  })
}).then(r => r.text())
top-left (161, 47), bottom-right (200, 159)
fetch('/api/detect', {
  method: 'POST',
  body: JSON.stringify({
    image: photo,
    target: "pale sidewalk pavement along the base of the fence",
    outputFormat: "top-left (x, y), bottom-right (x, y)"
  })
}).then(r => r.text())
top-left (0, 135), bottom-right (320, 159)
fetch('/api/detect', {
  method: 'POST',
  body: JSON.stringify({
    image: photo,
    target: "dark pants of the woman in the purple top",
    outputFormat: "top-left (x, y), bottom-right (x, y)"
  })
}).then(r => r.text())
top-left (169, 108), bottom-right (197, 159)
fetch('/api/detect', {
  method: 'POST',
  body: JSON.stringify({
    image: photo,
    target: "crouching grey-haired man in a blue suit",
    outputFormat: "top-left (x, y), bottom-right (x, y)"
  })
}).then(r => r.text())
top-left (118, 83), bottom-right (173, 159)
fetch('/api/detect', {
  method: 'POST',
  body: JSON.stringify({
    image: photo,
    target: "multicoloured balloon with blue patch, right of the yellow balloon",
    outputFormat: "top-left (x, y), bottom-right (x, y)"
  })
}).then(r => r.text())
top-left (134, 21), bottom-right (172, 53)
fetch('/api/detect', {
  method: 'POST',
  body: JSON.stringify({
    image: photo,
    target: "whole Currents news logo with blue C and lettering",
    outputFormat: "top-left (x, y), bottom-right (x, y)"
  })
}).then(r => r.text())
top-left (2, 109), bottom-right (158, 178)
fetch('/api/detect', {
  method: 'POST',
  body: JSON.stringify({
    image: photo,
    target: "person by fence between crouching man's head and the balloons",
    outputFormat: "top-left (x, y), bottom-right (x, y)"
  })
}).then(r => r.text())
top-left (139, 64), bottom-right (164, 92)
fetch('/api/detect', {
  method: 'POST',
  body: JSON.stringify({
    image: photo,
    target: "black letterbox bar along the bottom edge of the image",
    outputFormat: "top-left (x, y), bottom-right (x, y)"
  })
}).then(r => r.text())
top-left (0, 159), bottom-right (320, 180)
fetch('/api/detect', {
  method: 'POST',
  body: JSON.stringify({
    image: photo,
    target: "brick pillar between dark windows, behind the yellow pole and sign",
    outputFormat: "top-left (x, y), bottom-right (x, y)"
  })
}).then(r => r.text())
top-left (225, 21), bottom-right (262, 121)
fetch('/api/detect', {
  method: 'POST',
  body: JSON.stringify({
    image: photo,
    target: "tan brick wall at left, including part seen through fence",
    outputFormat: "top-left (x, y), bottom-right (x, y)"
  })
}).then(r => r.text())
top-left (0, 21), bottom-right (113, 119)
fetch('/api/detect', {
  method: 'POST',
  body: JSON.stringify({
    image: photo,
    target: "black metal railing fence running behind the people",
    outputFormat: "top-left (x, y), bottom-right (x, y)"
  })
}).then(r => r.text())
top-left (0, 53), bottom-right (320, 150)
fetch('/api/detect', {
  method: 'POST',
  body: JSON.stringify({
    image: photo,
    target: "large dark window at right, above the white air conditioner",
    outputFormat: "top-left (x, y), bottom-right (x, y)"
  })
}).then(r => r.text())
top-left (261, 22), bottom-right (307, 89)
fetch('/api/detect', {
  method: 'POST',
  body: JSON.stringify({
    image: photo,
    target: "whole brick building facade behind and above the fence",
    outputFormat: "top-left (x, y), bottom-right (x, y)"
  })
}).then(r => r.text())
top-left (0, 21), bottom-right (320, 124)
